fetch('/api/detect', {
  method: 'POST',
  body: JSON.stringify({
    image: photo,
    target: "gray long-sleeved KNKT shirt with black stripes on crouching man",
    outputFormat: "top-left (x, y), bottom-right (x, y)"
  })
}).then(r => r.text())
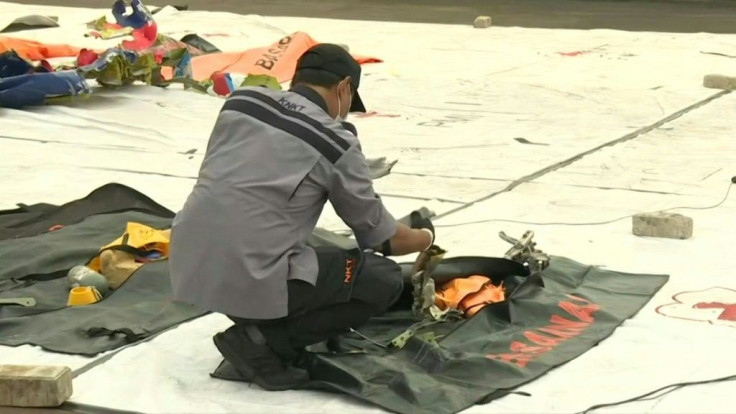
top-left (169, 86), bottom-right (396, 319)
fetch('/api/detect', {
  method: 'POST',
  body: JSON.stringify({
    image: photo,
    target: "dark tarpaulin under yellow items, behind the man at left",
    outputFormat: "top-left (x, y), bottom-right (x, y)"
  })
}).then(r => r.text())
top-left (0, 184), bottom-right (205, 355)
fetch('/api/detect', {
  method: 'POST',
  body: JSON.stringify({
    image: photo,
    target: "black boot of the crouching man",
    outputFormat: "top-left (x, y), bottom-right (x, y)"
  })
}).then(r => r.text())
top-left (213, 325), bottom-right (309, 391)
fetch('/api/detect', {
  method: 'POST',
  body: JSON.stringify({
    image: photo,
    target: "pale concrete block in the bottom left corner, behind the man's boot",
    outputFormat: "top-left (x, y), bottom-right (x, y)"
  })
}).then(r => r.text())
top-left (0, 365), bottom-right (72, 407)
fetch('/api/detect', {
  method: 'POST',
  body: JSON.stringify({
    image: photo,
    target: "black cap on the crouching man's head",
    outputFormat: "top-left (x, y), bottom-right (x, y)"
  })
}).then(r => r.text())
top-left (296, 43), bottom-right (365, 112)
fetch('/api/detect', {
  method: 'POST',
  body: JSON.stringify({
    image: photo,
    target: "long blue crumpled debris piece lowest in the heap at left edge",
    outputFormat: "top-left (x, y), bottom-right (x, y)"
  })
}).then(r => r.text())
top-left (0, 70), bottom-right (90, 109)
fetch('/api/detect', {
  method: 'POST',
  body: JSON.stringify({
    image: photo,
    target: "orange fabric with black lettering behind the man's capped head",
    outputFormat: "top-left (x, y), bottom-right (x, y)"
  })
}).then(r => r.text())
top-left (162, 32), bottom-right (381, 82)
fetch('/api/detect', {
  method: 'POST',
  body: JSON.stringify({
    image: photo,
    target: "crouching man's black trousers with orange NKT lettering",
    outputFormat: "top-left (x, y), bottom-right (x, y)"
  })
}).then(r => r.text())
top-left (230, 247), bottom-right (404, 359)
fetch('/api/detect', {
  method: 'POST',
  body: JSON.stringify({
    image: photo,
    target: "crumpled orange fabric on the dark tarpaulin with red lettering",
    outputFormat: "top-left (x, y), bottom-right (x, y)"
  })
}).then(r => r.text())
top-left (435, 275), bottom-right (506, 317)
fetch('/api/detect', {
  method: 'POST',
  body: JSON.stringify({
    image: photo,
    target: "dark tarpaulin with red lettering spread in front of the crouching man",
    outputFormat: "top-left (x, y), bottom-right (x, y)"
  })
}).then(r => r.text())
top-left (213, 257), bottom-right (668, 413)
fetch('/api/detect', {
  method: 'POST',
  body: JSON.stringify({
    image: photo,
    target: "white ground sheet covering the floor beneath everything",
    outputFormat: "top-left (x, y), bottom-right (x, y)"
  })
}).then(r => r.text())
top-left (0, 2), bottom-right (736, 413)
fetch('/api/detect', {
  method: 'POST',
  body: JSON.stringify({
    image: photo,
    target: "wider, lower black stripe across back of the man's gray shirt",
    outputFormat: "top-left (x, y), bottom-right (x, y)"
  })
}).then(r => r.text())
top-left (222, 99), bottom-right (342, 164)
